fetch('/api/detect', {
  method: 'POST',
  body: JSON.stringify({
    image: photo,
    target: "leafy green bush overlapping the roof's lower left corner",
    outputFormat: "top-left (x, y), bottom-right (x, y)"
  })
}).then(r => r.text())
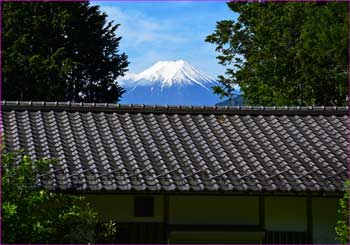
top-left (2, 149), bottom-right (116, 243)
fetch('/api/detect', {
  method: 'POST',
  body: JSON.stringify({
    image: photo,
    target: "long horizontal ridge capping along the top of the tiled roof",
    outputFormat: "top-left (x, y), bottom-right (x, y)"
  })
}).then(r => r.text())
top-left (1, 101), bottom-right (349, 115)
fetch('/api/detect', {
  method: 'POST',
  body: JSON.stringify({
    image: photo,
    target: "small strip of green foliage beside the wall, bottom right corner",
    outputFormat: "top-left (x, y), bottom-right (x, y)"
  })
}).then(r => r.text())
top-left (335, 181), bottom-right (350, 244)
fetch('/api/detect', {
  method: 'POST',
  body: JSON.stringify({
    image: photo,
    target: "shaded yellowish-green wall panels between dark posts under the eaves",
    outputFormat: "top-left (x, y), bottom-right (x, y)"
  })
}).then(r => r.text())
top-left (83, 194), bottom-right (339, 243)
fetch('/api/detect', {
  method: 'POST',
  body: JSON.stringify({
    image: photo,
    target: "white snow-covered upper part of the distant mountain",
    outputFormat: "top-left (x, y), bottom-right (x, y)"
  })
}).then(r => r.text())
top-left (119, 60), bottom-right (215, 88)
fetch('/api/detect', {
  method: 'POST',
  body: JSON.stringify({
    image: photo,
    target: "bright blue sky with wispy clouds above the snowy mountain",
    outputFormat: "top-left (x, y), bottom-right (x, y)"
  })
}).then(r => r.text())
top-left (91, 1), bottom-right (237, 78)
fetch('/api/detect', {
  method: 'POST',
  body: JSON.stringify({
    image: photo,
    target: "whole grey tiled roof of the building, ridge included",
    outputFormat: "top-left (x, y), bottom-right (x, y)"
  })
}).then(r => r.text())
top-left (2, 102), bottom-right (349, 192)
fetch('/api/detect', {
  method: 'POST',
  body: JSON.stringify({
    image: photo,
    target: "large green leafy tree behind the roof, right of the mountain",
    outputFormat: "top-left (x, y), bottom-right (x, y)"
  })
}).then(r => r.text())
top-left (206, 2), bottom-right (348, 106)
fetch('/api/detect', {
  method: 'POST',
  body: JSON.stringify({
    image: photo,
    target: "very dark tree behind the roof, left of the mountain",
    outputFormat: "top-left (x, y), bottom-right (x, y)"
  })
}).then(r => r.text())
top-left (2, 2), bottom-right (128, 102)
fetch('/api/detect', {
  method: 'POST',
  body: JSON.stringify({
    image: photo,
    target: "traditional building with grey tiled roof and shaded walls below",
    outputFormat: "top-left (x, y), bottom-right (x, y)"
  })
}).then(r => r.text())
top-left (2, 102), bottom-right (349, 243)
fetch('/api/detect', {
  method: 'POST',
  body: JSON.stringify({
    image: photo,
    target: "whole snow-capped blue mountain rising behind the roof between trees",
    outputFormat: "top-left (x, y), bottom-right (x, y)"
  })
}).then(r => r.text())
top-left (118, 60), bottom-right (220, 105)
